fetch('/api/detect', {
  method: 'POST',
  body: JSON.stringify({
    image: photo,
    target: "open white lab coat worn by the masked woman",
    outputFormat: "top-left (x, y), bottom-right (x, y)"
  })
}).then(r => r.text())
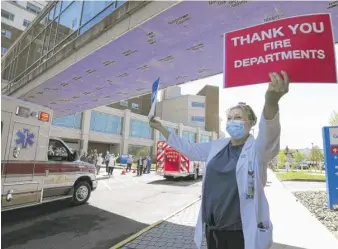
top-left (167, 113), bottom-right (280, 249)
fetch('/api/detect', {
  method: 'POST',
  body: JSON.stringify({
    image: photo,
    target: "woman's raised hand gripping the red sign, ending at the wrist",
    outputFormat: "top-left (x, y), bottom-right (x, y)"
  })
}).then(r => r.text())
top-left (265, 71), bottom-right (290, 105)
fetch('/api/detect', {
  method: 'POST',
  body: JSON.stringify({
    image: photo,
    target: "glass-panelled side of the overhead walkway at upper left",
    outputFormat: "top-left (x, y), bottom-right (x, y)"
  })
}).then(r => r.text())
top-left (1, 1), bottom-right (126, 88)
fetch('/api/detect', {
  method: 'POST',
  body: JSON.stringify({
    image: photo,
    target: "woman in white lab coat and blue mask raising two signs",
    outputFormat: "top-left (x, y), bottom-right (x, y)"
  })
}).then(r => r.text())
top-left (150, 71), bottom-right (289, 249)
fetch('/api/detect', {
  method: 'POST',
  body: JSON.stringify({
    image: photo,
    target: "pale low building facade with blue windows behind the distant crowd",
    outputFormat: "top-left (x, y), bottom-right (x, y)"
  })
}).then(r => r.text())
top-left (51, 106), bottom-right (217, 155)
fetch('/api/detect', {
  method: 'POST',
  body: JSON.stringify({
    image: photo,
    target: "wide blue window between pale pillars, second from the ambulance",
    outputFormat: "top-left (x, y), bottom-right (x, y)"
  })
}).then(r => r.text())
top-left (90, 111), bottom-right (123, 135)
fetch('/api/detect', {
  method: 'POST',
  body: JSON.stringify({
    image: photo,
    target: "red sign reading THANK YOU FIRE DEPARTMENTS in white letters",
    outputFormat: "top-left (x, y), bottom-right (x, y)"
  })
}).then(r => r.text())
top-left (224, 14), bottom-right (337, 87)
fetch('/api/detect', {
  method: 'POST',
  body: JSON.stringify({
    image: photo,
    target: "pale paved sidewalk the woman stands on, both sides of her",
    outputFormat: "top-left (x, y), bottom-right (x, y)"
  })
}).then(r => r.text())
top-left (117, 171), bottom-right (338, 249)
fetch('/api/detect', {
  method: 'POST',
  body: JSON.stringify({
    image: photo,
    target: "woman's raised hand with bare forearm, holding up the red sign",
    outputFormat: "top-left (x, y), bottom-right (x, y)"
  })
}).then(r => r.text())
top-left (264, 71), bottom-right (290, 120)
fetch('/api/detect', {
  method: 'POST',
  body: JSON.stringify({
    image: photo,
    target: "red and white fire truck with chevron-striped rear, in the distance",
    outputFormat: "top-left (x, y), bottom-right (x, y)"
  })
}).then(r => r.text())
top-left (156, 141), bottom-right (205, 180)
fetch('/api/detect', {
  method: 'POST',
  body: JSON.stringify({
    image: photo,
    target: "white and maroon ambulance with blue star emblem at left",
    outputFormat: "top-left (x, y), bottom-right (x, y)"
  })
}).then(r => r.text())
top-left (1, 96), bottom-right (97, 211)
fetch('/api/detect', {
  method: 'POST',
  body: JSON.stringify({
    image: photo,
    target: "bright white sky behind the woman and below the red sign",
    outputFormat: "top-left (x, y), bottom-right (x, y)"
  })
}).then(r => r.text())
top-left (181, 44), bottom-right (338, 149)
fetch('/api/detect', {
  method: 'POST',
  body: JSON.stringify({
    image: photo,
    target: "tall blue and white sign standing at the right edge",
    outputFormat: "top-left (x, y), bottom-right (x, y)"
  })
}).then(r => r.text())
top-left (323, 126), bottom-right (338, 209)
